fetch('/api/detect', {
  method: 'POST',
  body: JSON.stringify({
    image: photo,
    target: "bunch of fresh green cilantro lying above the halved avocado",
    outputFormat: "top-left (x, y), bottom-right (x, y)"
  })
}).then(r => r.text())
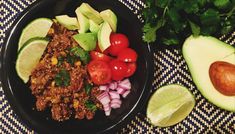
top-left (143, 0), bottom-right (235, 45)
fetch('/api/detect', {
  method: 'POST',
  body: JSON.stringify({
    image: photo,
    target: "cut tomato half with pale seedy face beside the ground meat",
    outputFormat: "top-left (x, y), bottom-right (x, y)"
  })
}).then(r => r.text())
top-left (88, 60), bottom-right (111, 85)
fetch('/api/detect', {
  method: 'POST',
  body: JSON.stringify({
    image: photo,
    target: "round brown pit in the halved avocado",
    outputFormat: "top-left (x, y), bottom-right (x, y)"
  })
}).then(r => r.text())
top-left (209, 59), bottom-right (235, 96)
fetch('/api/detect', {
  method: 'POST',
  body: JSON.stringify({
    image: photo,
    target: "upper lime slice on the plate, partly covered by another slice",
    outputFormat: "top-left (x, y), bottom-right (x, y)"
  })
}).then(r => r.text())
top-left (18, 18), bottom-right (53, 50)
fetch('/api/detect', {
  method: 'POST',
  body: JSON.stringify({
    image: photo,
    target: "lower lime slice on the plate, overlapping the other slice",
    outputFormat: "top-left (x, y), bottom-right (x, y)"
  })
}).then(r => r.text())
top-left (16, 37), bottom-right (49, 83)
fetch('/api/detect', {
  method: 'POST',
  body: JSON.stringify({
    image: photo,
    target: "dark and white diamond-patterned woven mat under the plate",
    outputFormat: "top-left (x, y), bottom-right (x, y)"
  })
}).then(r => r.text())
top-left (0, 0), bottom-right (235, 134)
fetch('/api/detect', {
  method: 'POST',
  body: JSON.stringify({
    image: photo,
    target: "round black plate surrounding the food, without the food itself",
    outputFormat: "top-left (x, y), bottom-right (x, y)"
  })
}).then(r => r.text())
top-left (0, 0), bottom-right (153, 133)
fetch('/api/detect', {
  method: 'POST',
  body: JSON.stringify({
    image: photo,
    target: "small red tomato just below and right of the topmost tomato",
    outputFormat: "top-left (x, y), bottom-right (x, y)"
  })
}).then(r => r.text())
top-left (118, 48), bottom-right (137, 62)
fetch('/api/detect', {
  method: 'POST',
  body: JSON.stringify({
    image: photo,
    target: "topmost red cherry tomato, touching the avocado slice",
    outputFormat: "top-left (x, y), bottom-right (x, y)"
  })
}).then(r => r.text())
top-left (108, 33), bottom-right (129, 56)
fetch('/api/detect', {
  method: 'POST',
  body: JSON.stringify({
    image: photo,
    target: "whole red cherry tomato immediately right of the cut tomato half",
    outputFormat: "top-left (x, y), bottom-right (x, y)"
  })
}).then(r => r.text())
top-left (109, 59), bottom-right (127, 80)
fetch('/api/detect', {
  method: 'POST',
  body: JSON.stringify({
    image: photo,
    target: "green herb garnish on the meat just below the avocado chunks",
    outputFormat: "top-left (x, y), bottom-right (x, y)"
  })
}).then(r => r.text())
top-left (70, 47), bottom-right (90, 64)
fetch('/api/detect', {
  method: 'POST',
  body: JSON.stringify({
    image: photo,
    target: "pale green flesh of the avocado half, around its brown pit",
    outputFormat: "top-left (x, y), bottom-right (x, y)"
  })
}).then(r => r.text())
top-left (182, 36), bottom-right (235, 111)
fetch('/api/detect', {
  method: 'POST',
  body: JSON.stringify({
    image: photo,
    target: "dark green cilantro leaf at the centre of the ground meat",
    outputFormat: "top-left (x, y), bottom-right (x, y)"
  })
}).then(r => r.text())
top-left (55, 69), bottom-right (70, 87)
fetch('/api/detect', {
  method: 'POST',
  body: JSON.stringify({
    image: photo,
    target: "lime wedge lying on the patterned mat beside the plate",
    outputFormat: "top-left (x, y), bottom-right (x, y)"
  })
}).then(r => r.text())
top-left (147, 84), bottom-right (195, 127)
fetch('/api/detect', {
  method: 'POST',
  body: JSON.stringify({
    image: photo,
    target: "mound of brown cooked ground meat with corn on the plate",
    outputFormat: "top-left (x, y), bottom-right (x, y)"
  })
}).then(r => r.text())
top-left (30, 23), bottom-right (102, 121)
